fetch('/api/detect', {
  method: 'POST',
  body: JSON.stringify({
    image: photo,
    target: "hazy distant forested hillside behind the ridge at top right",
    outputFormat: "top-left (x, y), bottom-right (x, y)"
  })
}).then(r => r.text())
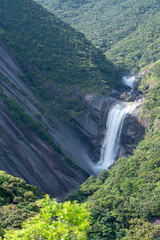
top-left (36, 0), bottom-right (160, 71)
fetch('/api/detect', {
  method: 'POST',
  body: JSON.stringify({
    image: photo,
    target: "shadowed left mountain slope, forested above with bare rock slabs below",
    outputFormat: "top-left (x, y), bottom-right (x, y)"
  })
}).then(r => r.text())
top-left (0, 0), bottom-right (119, 199)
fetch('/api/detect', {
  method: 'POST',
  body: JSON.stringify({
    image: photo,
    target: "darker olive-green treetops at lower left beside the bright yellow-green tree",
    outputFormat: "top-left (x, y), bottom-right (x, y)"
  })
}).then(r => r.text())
top-left (0, 171), bottom-right (40, 231)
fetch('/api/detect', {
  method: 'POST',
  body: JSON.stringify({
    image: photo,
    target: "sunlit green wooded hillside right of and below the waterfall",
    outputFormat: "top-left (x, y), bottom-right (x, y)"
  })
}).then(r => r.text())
top-left (65, 61), bottom-right (160, 240)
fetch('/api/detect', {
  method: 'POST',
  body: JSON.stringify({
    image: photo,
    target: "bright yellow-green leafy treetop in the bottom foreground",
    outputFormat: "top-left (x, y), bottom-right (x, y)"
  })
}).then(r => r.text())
top-left (5, 196), bottom-right (90, 240)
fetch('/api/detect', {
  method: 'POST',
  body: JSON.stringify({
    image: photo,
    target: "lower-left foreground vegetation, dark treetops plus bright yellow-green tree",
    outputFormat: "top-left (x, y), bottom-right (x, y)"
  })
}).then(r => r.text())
top-left (0, 171), bottom-right (89, 239)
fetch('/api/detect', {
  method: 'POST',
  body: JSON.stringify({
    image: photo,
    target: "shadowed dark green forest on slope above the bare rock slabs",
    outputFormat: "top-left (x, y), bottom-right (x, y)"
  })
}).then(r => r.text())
top-left (0, 0), bottom-right (119, 117)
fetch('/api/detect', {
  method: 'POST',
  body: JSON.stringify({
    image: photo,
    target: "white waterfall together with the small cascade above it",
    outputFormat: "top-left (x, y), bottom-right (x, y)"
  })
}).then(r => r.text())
top-left (94, 76), bottom-right (139, 173)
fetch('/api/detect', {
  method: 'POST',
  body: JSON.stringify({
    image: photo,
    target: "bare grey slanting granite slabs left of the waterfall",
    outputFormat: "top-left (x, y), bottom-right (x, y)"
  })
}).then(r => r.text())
top-left (0, 41), bottom-right (89, 199)
